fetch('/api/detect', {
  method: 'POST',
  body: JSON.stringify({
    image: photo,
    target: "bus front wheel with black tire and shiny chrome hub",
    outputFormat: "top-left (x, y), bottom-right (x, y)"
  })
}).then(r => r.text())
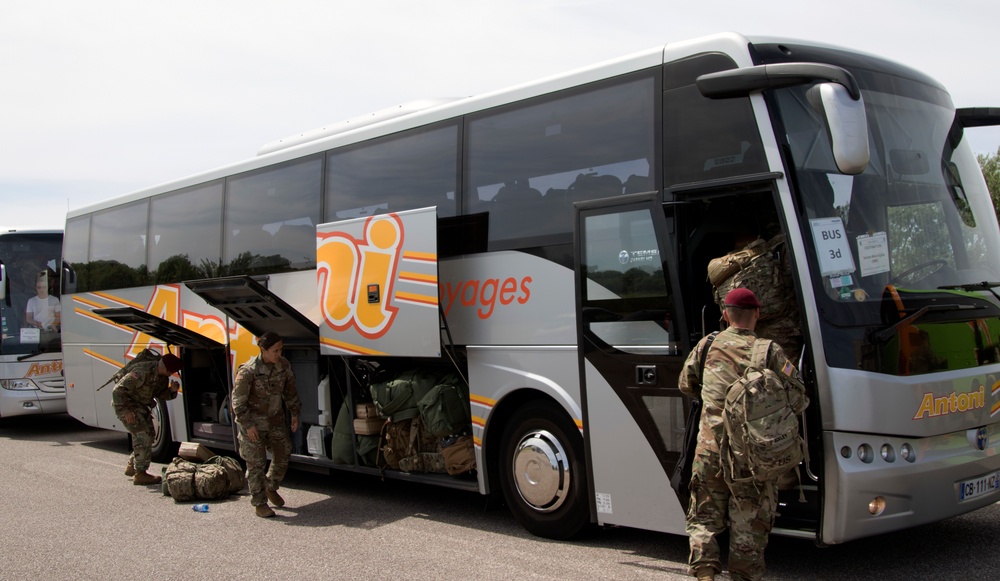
top-left (499, 401), bottom-right (590, 540)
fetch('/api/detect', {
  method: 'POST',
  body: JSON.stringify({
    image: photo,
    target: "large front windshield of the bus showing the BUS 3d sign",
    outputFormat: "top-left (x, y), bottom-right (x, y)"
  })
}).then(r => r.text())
top-left (775, 71), bottom-right (1000, 326)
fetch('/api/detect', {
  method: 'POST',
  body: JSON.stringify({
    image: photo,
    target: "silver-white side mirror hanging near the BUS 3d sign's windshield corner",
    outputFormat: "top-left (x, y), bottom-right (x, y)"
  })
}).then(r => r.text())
top-left (806, 83), bottom-right (869, 175)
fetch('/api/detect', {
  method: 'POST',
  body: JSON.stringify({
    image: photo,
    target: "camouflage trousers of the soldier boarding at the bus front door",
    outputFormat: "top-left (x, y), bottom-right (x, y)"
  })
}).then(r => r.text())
top-left (686, 446), bottom-right (778, 579)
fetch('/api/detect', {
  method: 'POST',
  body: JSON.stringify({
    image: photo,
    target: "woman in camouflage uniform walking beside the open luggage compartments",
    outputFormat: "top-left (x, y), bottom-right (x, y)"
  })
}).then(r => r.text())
top-left (233, 332), bottom-right (301, 518)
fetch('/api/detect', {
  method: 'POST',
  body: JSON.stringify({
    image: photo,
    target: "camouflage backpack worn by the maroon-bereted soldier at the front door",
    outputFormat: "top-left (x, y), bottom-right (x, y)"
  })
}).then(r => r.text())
top-left (720, 339), bottom-right (809, 483)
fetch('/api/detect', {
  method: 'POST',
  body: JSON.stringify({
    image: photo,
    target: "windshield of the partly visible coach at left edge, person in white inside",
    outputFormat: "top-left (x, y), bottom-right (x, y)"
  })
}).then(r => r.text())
top-left (0, 232), bottom-right (62, 355)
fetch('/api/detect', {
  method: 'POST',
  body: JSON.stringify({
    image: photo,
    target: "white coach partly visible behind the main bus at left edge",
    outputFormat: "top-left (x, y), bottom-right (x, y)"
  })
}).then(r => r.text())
top-left (0, 230), bottom-right (66, 418)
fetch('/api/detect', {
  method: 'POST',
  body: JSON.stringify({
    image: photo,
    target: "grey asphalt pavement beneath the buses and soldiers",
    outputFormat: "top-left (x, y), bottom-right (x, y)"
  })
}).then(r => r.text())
top-left (0, 415), bottom-right (1000, 581)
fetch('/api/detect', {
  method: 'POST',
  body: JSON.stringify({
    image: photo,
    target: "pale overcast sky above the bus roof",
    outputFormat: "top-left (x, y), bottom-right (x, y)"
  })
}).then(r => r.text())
top-left (0, 0), bottom-right (1000, 228)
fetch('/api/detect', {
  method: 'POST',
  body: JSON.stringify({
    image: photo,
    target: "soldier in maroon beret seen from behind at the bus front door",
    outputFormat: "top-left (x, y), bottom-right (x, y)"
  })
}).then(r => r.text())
top-left (679, 288), bottom-right (799, 580)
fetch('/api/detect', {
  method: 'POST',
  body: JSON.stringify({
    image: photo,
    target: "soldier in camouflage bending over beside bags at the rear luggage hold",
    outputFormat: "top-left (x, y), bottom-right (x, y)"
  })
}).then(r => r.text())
top-left (111, 353), bottom-right (181, 484)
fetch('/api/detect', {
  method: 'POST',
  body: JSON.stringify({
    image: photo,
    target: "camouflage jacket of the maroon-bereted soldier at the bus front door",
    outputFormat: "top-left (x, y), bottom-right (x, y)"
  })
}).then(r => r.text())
top-left (678, 327), bottom-right (804, 452)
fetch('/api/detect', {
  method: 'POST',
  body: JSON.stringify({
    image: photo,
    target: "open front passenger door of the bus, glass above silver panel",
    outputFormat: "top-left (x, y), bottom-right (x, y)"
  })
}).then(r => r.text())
top-left (575, 194), bottom-right (687, 534)
